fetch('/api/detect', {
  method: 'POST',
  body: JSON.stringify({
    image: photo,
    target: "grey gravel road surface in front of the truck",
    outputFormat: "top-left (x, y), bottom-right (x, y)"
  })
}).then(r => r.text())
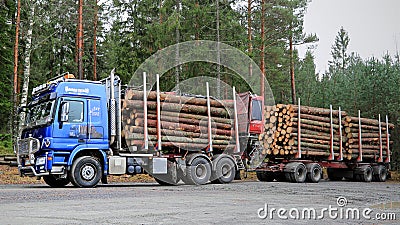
top-left (0, 181), bottom-right (400, 224)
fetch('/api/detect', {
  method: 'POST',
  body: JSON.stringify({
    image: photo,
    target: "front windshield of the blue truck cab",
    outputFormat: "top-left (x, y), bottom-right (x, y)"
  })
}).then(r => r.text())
top-left (26, 100), bottom-right (54, 127)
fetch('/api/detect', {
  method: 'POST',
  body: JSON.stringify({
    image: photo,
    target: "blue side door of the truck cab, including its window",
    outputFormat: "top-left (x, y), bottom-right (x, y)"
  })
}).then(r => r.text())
top-left (53, 98), bottom-right (88, 150)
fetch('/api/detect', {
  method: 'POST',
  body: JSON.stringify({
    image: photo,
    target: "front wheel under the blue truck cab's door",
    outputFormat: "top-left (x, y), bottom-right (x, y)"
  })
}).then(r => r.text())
top-left (70, 156), bottom-right (102, 188)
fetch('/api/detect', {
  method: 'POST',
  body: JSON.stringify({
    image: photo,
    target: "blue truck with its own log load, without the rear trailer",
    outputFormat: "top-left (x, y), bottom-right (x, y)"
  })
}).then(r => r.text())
top-left (16, 72), bottom-right (263, 187)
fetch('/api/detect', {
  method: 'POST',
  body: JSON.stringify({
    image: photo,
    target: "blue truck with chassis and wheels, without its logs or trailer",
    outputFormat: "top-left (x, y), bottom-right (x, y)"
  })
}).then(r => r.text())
top-left (16, 72), bottom-right (262, 187)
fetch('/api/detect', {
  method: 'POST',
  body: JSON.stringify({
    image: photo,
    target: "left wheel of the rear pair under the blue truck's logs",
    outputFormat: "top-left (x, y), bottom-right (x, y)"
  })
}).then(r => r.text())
top-left (185, 157), bottom-right (211, 185)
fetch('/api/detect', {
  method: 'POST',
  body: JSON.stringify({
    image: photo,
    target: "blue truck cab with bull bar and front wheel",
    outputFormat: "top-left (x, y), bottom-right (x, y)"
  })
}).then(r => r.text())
top-left (17, 74), bottom-right (113, 186)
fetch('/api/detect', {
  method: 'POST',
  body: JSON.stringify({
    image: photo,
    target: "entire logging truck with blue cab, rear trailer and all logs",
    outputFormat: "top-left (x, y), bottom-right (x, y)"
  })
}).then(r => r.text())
top-left (15, 72), bottom-right (393, 187)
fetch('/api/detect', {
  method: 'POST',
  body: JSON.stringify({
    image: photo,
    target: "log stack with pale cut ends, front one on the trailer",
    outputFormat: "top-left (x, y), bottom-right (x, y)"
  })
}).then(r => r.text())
top-left (261, 104), bottom-right (347, 157)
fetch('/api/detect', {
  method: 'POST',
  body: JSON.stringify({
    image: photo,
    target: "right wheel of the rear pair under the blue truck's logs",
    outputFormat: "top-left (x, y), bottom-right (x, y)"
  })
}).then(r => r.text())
top-left (211, 158), bottom-right (236, 184)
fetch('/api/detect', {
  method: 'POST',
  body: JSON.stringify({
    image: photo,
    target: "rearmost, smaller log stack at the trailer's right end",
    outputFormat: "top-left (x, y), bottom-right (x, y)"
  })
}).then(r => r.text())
top-left (344, 117), bottom-right (394, 161)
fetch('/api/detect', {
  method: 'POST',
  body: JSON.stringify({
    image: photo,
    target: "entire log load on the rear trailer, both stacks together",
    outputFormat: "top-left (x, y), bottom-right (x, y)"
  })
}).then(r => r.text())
top-left (259, 104), bottom-right (394, 160)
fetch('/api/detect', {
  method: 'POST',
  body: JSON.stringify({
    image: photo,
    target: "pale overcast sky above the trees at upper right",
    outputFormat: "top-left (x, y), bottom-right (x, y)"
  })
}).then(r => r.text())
top-left (299, 0), bottom-right (400, 73)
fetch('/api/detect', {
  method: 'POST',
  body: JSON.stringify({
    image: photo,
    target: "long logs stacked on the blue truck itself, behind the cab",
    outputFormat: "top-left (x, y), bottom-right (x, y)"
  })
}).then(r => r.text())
top-left (122, 89), bottom-right (234, 151)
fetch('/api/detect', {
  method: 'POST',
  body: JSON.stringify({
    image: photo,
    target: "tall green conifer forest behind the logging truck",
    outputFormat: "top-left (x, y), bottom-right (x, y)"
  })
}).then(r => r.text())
top-left (0, 0), bottom-right (400, 169)
